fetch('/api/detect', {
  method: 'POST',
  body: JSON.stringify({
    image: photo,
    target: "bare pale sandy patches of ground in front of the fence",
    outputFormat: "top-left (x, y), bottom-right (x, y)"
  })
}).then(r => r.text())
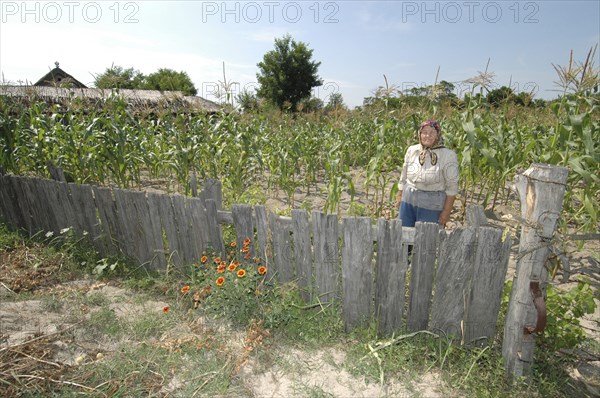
top-left (0, 281), bottom-right (446, 398)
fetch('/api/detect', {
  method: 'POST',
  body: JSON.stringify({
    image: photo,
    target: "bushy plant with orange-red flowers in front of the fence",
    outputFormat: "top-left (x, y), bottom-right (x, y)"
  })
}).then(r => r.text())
top-left (193, 238), bottom-right (271, 324)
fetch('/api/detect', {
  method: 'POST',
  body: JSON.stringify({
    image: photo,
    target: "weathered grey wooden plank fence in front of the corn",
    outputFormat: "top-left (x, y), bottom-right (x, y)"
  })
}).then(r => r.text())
top-left (0, 175), bottom-right (511, 342)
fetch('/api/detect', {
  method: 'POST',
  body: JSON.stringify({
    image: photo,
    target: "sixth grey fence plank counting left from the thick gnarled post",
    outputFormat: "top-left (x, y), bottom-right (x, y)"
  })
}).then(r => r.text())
top-left (312, 211), bottom-right (341, 303)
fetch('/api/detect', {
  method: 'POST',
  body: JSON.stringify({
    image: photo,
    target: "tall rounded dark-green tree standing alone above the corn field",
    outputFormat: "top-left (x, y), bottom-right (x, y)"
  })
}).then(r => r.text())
top-left (256, 35), bottom-right (323, 111)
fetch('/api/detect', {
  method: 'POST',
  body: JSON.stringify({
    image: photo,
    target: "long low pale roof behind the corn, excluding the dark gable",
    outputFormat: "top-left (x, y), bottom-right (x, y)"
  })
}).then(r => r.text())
top-left (0, 83), bottom-right (221, 112)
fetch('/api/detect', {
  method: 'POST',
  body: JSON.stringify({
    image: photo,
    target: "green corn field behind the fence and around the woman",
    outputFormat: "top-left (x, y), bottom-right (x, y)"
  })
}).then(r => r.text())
top-left (0, 89), bottom-right (600, 231)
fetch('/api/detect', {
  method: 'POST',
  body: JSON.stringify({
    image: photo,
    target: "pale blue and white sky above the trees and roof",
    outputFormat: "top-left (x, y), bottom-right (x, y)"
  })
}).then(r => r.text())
top-left (0, 0), bottom-right (600, 108)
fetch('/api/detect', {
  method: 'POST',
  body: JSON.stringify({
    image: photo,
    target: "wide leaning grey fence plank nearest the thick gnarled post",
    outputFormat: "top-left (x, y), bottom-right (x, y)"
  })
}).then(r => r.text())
top-left (464, 227), bottom-right (512, 345)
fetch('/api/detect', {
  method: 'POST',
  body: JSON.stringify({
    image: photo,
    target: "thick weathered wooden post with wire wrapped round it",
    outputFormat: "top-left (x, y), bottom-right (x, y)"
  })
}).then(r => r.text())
top-left (502, 164), bottom-right (568, 377)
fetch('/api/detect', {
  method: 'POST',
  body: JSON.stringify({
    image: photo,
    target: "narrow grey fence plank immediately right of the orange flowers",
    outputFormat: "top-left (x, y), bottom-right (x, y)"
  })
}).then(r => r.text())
top-left (269, 213), bottom-right (295, 283)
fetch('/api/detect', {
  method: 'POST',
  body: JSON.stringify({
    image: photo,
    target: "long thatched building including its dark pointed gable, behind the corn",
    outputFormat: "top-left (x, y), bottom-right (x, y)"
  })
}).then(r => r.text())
top-left (0, 63), bottom-right (221, 113)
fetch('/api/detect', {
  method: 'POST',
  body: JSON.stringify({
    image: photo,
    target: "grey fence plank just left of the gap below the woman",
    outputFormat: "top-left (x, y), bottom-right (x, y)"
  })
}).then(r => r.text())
top-left (375, 219), bottom-right (408, 335)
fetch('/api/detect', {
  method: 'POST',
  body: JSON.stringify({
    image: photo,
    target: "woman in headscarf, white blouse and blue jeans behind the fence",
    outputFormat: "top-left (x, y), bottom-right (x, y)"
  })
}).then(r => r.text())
top-left (396, 120), bottom-right (458, 227)
